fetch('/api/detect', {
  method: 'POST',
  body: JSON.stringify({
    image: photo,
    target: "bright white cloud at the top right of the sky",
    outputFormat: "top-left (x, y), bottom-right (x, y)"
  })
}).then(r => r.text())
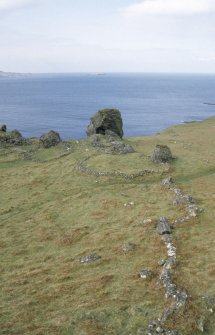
top-left (122, 0), bottom-right (215, 17)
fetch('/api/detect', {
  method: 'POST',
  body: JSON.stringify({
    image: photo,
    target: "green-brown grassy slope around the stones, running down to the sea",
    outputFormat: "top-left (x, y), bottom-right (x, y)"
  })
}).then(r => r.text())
top-left (0, 118), bottom-right (215, 335)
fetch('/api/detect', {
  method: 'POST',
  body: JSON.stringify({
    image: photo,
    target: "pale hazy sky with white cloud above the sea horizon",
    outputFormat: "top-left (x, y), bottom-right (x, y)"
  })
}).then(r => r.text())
top-left (0, 0), bottom-right (215, 73)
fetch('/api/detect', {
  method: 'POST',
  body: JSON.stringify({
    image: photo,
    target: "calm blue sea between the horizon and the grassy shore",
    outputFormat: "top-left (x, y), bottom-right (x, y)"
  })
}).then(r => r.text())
top-left (0, 74), bottom-right (215, 139)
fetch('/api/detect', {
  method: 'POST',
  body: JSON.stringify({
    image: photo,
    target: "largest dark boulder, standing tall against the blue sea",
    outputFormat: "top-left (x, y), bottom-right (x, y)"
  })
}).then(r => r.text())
top-left (87, 109), bottom-right (123, 138)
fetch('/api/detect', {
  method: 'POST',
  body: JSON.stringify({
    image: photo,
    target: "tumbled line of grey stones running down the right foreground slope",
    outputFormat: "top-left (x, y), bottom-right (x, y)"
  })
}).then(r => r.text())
top-left (145, 176), bottom-right (208, 335)
